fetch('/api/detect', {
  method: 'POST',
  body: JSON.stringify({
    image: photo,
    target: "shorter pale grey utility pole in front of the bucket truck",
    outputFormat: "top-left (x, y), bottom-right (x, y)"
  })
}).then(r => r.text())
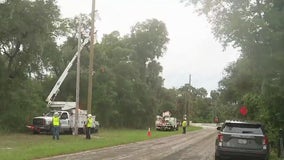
top-left (74, 16), bottom-right (82, 135)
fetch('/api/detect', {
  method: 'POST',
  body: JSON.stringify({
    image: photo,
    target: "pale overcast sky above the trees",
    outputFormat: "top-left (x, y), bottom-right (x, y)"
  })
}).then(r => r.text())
top-left (57, 0), bottom-right (239, 93)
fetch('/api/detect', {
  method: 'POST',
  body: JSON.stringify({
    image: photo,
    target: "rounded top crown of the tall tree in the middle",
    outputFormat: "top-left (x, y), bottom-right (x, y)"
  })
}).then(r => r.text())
top-left (129, 19), bottom-right (169, 80)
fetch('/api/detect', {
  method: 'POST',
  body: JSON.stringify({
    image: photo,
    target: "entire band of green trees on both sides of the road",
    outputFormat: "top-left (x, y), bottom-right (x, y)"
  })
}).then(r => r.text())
top-left (0, 0), bottom-right (284, 148)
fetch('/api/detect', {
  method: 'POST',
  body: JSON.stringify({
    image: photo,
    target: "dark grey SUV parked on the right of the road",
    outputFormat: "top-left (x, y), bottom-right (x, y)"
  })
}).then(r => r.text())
top-left (215, 121), bottom-right (269, 160)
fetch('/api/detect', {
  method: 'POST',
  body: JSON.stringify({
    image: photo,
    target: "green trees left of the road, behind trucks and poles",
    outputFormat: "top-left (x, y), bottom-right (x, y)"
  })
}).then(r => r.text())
top-left (0, 0), bottom-right (213, 131)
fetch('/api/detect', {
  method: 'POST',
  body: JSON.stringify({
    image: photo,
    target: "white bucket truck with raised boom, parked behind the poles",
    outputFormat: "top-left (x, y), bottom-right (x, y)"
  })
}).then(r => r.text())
top-left (27, 36), bottom-right (99, 133)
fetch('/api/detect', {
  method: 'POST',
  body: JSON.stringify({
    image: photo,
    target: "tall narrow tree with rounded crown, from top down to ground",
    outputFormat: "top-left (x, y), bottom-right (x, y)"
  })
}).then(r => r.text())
top-left (117, 19), bottom-right (168, 129)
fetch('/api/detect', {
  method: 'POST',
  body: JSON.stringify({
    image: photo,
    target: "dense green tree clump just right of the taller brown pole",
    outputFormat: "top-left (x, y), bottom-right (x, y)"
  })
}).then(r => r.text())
top-left (72, 20), bottom-right (167, 128)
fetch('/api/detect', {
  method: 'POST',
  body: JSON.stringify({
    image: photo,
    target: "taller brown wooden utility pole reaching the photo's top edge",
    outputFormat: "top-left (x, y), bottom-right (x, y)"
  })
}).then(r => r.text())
top-left (87, 0), bottom-right (96, 114)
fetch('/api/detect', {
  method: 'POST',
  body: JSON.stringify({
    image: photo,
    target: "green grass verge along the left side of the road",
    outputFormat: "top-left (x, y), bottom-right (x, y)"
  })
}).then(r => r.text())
top-left (0, 126), bottom-right (201, 160)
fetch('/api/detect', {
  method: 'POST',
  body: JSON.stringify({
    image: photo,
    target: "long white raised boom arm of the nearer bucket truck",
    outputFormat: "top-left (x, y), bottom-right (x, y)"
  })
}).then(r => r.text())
top-left (45, 39), bottom-right (89, 106)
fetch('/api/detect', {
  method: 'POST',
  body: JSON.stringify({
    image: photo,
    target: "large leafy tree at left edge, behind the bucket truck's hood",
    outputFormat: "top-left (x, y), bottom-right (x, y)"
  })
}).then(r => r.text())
top-left (0, 0), bottom-right (60, 130)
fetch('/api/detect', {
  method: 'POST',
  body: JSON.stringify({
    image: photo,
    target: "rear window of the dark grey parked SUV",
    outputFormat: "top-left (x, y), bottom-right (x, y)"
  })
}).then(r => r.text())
top-left (223, 123), bottom-right (263, 135)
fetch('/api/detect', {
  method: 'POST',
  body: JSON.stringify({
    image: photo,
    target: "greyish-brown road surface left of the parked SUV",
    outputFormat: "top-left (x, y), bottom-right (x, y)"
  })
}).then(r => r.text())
top-left (41, 127), bottom-right (217, 160)
